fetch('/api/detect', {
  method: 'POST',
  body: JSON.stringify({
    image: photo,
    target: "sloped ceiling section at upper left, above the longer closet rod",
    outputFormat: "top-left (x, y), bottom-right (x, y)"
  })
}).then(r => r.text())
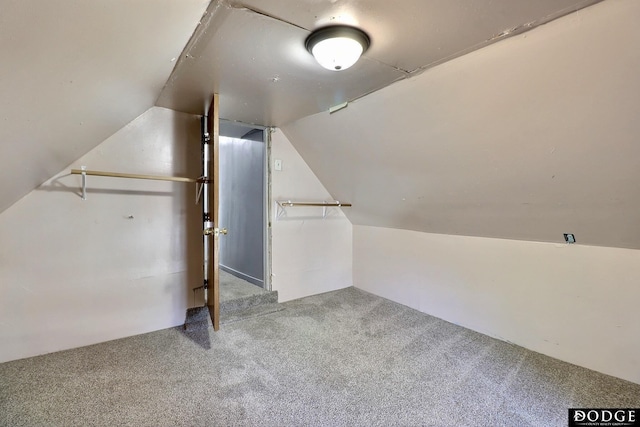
top-left (0, 0), bottom-right (209, 212)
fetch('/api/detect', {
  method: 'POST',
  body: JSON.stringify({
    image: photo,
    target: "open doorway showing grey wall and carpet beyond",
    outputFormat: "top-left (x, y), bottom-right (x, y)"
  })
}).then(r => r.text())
top-left (219, 120), bottom-right (270, 310)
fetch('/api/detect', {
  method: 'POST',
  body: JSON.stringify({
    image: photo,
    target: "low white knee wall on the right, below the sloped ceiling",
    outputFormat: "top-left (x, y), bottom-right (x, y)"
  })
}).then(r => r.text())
top-left (353, 225), bottom-right (640, 384)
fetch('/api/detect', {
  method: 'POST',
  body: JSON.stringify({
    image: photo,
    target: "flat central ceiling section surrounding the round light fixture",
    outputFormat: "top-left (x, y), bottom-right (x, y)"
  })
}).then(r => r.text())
top-left (157, 0), bottom-right (599, 126)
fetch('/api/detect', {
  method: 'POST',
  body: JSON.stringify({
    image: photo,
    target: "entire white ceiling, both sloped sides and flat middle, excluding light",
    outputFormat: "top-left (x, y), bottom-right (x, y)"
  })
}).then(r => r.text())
top-left (5, 0), bottom-right (640, 248)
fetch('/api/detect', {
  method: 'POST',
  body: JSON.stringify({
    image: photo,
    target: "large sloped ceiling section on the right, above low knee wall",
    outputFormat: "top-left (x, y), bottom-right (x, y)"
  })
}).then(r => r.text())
top-left (282, 0), bottom-right (640, 249)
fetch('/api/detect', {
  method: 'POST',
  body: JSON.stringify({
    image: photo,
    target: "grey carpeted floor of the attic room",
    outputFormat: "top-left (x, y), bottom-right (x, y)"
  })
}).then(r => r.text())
top-left (0, 288), bottom-right (640, 427)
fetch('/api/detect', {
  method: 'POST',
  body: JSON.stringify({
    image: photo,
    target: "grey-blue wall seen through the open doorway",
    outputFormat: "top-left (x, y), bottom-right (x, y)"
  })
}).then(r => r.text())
top-left (219, 136), bottom-right (267, 287)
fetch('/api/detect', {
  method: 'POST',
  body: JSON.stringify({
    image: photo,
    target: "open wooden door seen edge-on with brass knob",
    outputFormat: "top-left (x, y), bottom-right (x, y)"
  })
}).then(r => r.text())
top-left (205, 93), bottom-right (222, 331)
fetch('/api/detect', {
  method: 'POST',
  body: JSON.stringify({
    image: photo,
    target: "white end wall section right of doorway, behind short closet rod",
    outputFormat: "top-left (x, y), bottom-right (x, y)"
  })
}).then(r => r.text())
top-left (271, 130), bottom-right (352, 302)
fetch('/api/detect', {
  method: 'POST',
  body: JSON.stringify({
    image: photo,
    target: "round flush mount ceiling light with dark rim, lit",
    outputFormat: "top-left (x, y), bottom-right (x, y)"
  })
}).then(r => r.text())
top-left (305, 25), bottom-right (370, 71)
